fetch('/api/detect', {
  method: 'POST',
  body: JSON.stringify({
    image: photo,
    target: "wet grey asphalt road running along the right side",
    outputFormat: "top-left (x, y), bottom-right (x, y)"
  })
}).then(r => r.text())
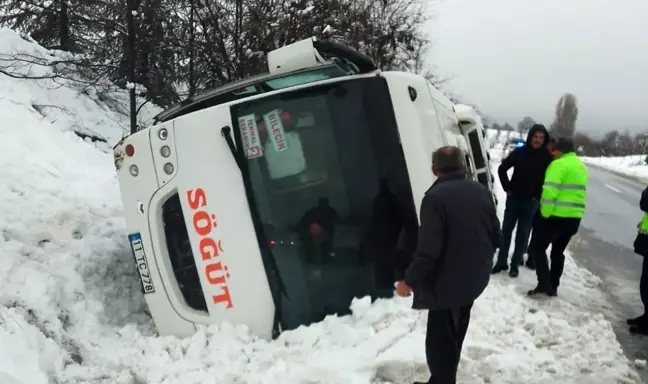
top-left (570, 166), bottom-right (648, 372)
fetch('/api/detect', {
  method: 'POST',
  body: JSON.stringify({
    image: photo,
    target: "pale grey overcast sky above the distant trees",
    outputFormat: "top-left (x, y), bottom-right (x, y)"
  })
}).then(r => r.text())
top-left (428, 0), bottom-right (648, 133)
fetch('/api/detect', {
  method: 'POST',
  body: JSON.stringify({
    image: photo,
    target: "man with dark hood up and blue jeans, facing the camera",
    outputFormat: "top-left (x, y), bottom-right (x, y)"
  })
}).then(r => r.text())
top-left (493, 124), bottom-right (551, 277)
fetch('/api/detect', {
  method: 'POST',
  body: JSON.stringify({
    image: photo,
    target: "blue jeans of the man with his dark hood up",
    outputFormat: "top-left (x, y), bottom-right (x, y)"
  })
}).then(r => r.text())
top-left (497, 196), bottom-right (538, 268)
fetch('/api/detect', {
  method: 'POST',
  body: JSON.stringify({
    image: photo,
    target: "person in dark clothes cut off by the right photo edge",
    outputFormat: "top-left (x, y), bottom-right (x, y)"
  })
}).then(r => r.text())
top-left (627, 188), bottom-right (648, 335)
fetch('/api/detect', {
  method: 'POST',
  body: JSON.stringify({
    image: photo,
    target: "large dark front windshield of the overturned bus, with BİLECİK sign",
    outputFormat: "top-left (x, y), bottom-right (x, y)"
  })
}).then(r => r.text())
top-left (231, 76), bottom-right (417, 329)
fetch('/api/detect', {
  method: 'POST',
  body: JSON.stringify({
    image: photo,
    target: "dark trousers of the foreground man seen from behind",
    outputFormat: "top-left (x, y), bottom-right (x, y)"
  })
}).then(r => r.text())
top-left (425, 304), bottom-right (472, 384)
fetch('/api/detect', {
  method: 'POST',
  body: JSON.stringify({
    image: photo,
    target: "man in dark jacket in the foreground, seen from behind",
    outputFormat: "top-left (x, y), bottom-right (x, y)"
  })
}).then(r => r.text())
top-left (396, 147), bottom-right (500, 384)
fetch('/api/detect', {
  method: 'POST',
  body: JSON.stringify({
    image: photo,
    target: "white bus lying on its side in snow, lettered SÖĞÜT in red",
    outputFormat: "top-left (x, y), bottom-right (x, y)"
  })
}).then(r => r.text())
top-left (114, 38), bottom-right (491, 338)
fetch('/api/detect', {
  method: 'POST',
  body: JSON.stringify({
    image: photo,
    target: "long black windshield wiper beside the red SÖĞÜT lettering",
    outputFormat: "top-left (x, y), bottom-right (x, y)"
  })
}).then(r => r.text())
top-left (221, 126), bottom-right (288, 338)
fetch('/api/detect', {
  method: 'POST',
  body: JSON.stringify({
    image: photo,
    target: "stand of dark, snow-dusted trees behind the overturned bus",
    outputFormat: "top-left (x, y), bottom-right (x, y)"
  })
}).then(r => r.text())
top-left (0, 0), bottom-right (443, 135)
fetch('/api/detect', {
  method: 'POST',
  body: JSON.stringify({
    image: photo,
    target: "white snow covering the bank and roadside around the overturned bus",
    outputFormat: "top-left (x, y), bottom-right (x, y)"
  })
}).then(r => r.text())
top-left (0, 30), bottom-right (639, 384)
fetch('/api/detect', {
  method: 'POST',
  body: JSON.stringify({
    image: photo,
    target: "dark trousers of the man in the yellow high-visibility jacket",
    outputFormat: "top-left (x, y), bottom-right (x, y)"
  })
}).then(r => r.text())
top-left (529, 217), bottom-right (580, 290)
